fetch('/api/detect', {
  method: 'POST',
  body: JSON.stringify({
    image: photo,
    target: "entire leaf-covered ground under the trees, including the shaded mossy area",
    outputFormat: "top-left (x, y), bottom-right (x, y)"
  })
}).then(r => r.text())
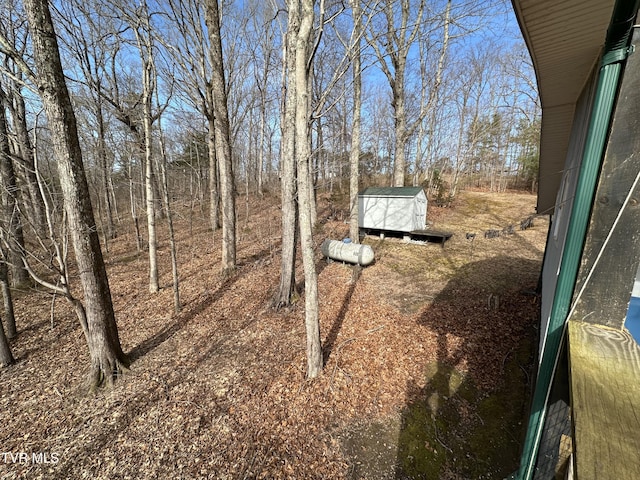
top-left (0, 192), bottom-right (547, 479)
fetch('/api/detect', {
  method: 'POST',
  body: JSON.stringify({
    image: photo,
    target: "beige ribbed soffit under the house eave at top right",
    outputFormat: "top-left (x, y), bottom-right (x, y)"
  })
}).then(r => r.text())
top-left (512, 0), bottom-right (615, 213)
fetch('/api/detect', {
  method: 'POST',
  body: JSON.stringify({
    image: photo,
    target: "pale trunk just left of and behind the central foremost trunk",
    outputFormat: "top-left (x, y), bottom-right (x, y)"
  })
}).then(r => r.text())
top-left (273, 2), bottom-right (300, 308)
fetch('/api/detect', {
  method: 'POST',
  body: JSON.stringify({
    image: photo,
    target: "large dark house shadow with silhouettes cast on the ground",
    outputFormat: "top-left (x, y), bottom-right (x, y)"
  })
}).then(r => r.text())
top-left (395, 256), bottom-right (540, 479)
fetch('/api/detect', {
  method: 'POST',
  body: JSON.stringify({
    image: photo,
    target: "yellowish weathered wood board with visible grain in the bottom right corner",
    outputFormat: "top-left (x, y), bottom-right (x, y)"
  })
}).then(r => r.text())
top-left (569, 321), bottom-right (640, 480)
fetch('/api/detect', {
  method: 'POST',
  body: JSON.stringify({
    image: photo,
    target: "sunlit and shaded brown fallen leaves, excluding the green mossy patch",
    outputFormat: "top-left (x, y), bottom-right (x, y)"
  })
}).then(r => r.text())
top-left (0, 189), bottom-right (544, 479)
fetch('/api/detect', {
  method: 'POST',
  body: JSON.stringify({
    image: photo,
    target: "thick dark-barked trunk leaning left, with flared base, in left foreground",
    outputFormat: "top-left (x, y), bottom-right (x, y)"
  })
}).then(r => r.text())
top-left (24, 0), bottom-right (128, 387)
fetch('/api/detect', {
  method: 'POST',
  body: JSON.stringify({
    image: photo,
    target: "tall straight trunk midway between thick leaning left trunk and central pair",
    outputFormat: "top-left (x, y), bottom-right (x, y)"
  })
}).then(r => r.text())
top-left (205, 0), bottom-right (236, 276)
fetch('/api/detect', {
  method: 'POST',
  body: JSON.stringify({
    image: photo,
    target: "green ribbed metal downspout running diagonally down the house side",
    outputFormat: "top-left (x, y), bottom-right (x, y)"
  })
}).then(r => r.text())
top-left (516, 0), bottom-right (638, 480)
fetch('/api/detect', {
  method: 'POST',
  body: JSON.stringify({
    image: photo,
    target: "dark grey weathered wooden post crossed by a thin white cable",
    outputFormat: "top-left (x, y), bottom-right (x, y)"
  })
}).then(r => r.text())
top-left (574, 31), bottom-right (640, 330)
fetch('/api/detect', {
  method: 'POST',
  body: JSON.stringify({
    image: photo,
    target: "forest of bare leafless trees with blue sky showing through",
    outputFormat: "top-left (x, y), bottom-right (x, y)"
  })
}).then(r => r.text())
top-left (0, 0), bottom-right (540, 387)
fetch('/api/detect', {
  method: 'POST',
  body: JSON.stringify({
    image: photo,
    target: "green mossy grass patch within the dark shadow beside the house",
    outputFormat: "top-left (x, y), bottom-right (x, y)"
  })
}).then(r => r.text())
top-left (396, 345), bottom-right (531, 479)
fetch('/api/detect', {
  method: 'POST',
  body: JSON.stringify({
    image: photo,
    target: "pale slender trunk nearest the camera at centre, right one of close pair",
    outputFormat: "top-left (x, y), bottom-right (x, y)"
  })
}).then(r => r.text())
top-left (293, 0), bottom-right (322, 378)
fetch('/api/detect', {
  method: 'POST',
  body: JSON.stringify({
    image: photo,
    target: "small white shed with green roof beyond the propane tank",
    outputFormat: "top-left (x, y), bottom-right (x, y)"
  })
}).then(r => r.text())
top-left (358, 187), bottom-right (427, 232)
